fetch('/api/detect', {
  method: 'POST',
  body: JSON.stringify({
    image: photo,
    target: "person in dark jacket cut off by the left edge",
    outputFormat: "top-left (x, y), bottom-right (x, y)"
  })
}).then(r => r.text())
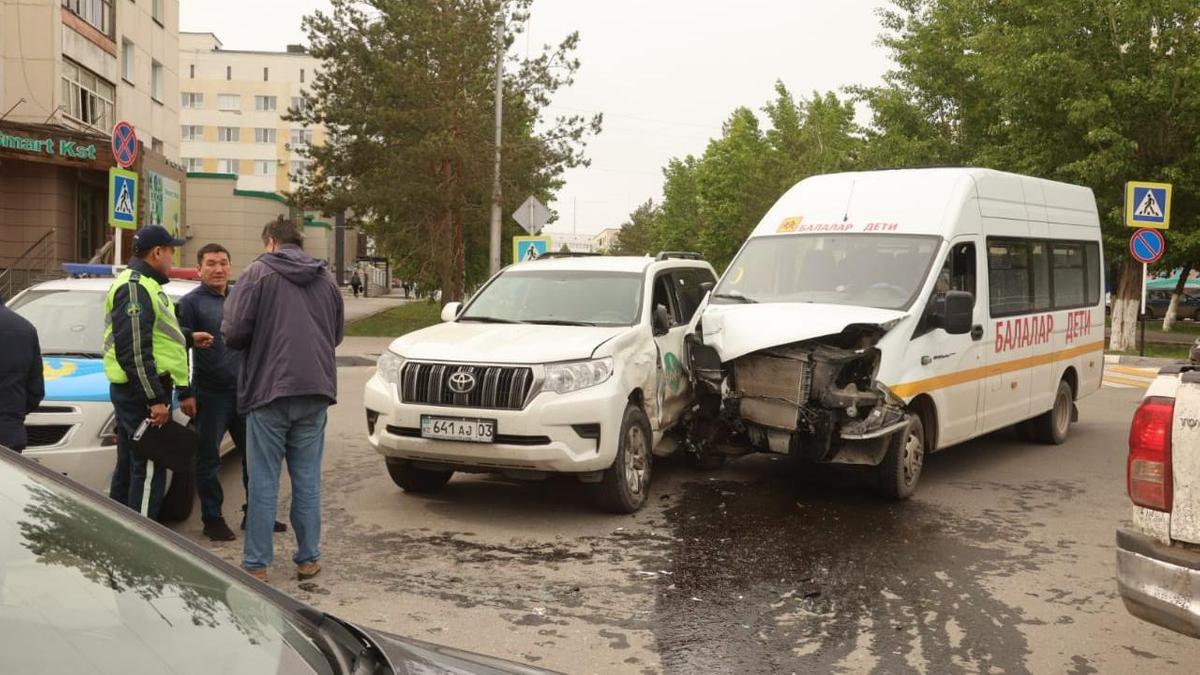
top-left (0, 303), bottom-right (46, 453)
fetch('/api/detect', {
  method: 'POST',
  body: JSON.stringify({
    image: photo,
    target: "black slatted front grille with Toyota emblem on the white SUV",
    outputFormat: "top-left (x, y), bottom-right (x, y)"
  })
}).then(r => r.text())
top-left (400, 363), bottom-right (533, 410)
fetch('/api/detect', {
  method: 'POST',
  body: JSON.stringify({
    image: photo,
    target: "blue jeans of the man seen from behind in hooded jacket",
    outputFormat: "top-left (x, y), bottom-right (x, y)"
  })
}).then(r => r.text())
top-left (242, 396), bottom-right (329, 569)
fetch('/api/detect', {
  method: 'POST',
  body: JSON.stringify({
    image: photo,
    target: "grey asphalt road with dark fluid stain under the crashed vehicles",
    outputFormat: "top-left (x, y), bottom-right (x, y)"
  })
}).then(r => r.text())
top-left (178, 368), bottom-right (1200, 674)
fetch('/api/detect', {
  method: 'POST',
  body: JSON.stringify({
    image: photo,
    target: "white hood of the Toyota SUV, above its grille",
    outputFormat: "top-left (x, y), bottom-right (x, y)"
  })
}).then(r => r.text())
top-left (390, 322), bottom-right (630, 364)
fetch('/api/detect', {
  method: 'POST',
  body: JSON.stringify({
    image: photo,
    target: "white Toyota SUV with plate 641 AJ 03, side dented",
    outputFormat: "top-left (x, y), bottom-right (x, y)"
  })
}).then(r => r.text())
top-left (365, 253), bottom-right (716, 513)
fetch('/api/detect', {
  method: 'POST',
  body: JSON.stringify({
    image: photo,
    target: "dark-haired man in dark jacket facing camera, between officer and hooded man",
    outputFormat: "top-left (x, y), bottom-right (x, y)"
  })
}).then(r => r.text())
top-left (179, 244), bottom-right (288, 542)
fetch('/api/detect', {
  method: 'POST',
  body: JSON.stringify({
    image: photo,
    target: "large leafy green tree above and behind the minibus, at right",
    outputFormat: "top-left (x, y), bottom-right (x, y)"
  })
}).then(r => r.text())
top-left (858, 0), bottom-right (1200, 350)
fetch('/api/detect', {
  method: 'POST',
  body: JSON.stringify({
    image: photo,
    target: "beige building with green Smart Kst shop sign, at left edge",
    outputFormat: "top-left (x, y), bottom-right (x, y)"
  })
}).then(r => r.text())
top-left (0, 0), bottom-right (184, 269)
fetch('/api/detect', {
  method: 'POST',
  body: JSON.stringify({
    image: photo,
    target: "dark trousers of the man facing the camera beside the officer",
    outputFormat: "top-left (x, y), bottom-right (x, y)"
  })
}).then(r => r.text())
top-left (196, 387), bottom-right (246, 522)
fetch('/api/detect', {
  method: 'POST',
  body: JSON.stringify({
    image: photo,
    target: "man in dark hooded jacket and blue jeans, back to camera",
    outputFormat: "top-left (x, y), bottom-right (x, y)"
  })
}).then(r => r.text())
top-left (221, 216), bottom-right (344, 581)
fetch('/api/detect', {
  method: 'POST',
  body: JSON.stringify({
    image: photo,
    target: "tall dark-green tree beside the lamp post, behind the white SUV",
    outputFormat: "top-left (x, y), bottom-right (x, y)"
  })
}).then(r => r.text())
top-left (294, 0), bottom-right (600, 300)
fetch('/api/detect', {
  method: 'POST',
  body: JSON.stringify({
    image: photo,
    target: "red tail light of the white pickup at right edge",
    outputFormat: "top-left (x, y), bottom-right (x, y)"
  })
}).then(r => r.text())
top-left (1126, 396), bottom-right (1175, 513)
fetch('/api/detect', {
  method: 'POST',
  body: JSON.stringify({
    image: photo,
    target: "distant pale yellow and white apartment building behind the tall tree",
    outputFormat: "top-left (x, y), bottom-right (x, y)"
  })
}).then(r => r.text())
top-left (179, 32), bottom-right (325, 193)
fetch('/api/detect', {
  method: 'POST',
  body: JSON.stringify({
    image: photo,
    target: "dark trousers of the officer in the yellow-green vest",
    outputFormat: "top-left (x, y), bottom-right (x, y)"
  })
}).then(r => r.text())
top-left (108, 383), bottom-right (167, 519)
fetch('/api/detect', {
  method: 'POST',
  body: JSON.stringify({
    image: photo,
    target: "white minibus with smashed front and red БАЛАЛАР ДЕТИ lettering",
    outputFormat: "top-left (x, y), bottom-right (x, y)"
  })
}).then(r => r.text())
top-left (689, 168), bottom-right (1104, 498)
